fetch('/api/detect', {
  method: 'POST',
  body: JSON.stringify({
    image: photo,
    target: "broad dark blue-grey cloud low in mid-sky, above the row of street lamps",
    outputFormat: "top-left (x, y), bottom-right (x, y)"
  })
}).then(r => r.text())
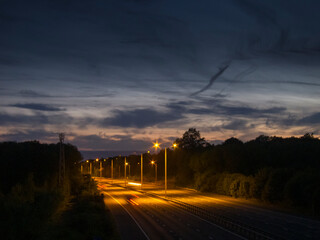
top-left (100, 108), bottom-right (183, 128)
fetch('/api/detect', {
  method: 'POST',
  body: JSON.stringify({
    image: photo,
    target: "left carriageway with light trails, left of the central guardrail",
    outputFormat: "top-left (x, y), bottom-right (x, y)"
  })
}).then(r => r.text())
top-left (95, 178), bottom-right (244, 240)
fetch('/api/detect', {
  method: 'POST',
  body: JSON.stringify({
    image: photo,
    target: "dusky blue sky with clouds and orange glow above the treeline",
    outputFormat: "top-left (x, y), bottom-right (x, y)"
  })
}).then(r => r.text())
top-left (0, 0), bottom-right (320, 150)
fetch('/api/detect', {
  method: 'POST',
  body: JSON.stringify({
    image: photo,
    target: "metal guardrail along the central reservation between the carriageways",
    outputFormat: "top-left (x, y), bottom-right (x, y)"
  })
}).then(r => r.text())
top-left (114, 184), bottom-right (285, 240)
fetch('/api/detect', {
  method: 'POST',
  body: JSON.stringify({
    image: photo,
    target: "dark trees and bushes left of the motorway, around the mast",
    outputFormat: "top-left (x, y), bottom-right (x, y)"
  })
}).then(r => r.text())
top-left (0, 141), bottom-right (117, 240)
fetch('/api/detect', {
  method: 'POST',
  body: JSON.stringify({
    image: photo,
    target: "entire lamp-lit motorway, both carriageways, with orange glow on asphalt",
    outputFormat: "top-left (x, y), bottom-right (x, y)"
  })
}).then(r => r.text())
top-left (95, 178), bottom-right (320, 240)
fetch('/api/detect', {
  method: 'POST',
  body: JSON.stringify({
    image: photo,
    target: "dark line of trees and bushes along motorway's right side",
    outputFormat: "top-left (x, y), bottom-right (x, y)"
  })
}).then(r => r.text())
top-left (116, 128), bottom-right (320, 217)
